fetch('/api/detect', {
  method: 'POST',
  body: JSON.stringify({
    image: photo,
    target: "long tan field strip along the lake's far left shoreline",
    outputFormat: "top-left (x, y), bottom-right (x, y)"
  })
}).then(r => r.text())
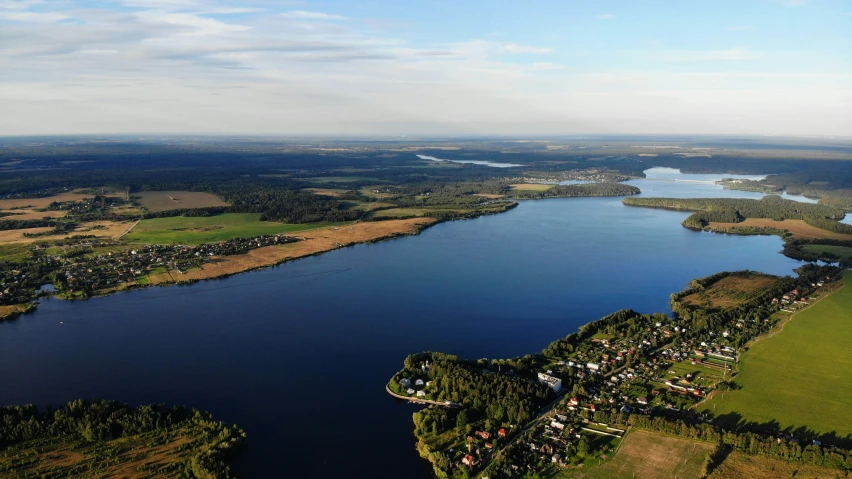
top-left (148, 218), bottom-right (435, 284)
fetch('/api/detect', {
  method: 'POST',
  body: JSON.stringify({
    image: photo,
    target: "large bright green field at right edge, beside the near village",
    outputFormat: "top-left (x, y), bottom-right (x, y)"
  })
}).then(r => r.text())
top-left (701, 272), bottom-right (852, 445)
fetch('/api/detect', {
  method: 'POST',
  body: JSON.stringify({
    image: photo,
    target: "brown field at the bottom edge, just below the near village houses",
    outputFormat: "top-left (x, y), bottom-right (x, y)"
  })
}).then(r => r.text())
top-left (558, 430), bottom-right (716, 479)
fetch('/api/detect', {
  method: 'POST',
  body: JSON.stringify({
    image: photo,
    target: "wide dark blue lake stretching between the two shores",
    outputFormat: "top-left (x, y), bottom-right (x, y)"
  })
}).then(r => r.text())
top-left (0, 169), bottom-right (812, 479)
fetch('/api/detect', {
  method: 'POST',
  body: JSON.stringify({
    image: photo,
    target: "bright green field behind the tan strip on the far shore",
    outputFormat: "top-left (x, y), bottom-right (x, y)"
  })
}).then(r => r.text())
top-left (124, 213), bottom-right (338, 244)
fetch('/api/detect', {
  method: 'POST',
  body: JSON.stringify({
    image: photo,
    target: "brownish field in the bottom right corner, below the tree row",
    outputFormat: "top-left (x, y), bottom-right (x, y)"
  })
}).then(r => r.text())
top-left (708, 451), bottom-right (852, 479)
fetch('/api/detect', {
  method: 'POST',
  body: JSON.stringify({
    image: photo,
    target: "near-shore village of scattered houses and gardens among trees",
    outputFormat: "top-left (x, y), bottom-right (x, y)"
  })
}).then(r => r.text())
top-left (389, 264), bottom-right (837, 477)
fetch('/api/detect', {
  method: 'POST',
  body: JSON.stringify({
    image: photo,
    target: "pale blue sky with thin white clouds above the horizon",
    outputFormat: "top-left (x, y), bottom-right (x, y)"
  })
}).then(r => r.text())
top-left (0, 0), bottom-right (852, 137)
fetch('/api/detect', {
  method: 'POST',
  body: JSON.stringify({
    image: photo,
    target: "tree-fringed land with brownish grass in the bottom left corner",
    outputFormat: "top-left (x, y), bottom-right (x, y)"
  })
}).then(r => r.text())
top-left (0, 400), bottom-right (246, 479)
